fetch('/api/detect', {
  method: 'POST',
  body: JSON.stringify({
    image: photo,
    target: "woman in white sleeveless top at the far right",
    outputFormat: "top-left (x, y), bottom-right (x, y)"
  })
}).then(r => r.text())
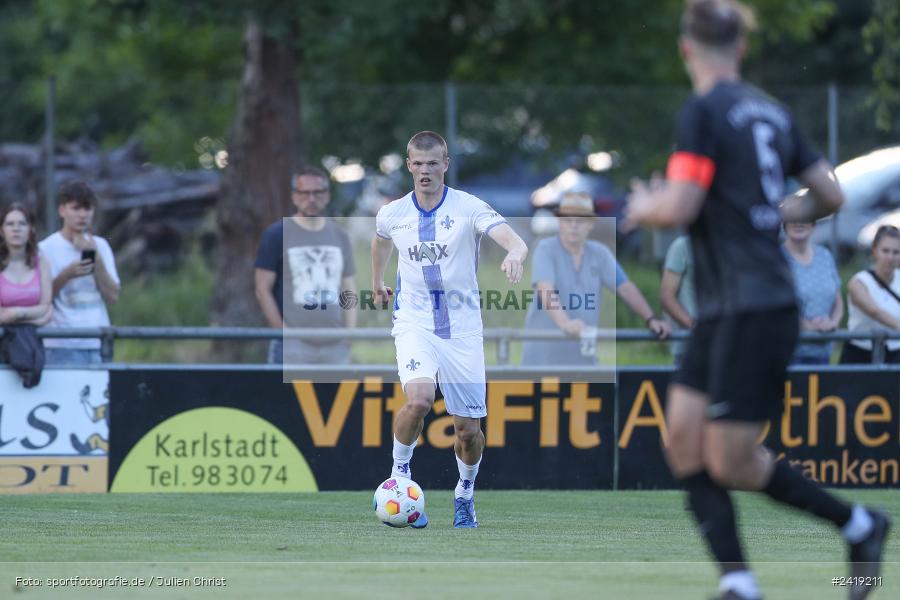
top-left (841, 225), bottom-right (900, 363)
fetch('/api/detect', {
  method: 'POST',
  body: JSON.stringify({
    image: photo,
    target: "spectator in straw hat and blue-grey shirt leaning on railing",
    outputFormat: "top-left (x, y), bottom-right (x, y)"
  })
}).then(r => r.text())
top-left (521, 193), bottom-right (669, 365)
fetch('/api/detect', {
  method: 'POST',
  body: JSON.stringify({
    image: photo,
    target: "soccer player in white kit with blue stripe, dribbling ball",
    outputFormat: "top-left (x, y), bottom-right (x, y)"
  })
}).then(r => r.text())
top-left (372, 131), bottom-right (528, 529)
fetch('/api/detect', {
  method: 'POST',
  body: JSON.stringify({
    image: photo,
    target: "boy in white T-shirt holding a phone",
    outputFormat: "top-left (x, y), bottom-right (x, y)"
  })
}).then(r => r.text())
top-left (40, 181), bottom-right (119, 364)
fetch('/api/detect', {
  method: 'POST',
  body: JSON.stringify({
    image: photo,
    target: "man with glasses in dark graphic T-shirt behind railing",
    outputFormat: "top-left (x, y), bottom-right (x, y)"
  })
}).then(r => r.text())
top-left (255, 166), bottom-right (356, 365)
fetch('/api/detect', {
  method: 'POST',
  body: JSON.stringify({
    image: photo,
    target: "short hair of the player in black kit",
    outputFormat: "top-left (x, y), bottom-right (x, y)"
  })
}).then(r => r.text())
top-left (681, 0), bottom-right (756, 50)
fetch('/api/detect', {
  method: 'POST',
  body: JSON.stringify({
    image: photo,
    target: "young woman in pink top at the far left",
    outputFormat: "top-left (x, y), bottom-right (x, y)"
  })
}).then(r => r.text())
top-left (0, 203), bottom-right (53, 325)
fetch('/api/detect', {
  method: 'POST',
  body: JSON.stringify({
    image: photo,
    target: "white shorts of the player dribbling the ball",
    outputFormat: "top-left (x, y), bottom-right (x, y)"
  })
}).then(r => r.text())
top-left (392, 327), bottom-right (487, 419)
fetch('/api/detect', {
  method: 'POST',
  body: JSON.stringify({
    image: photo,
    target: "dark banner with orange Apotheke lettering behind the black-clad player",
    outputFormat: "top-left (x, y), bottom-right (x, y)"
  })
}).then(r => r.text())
top-left (617, 370), bottom-right (900, 489)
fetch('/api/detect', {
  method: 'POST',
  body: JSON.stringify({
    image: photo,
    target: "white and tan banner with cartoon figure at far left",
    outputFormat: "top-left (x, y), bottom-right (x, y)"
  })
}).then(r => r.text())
top-left (0, 369), bottom-right (110, 494)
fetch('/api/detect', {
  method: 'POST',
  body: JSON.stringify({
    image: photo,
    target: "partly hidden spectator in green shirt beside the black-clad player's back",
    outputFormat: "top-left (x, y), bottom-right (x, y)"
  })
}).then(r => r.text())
top-left (659, 235), bottom-right (697, 365)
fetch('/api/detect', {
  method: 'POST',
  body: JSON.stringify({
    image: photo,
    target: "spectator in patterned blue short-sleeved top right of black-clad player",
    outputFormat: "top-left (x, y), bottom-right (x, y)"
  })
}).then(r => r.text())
top-left (782, 222), bottom-right (844, 365)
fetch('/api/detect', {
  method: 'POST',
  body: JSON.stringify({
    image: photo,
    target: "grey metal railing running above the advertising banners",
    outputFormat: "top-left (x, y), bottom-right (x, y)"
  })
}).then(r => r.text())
top-left (7, 327), bottom-right (900, 365)
